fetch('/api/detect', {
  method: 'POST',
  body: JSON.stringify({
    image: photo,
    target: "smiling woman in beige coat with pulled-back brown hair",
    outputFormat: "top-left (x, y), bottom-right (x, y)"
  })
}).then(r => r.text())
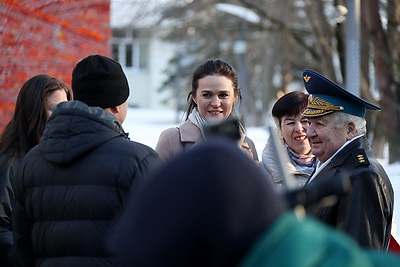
top-left (155, 59), bottom-right (258, 162)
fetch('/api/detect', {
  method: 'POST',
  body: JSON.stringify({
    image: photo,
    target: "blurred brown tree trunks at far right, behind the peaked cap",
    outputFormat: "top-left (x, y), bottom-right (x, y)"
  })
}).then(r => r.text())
top-left (363, 0), bottom-right (400, 162)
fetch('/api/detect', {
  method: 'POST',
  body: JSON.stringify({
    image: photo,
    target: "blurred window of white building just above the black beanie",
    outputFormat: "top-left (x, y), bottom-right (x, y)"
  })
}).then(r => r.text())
top-left (112, 29), bottom-right (149, 70)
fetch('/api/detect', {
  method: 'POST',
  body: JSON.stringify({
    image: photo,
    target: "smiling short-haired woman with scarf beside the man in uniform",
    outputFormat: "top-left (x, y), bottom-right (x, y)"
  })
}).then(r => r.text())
top-left (259, 91), bottom-right (317, 189)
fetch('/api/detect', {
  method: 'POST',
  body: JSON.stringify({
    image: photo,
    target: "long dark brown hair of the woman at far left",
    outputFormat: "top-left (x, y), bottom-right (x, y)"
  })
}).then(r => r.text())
top-left (0, 74), bottom-right (72, 163)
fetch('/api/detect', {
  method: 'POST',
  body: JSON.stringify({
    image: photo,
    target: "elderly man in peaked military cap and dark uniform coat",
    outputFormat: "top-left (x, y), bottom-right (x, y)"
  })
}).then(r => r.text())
top-left (303, 70), bottom-right (394, 250)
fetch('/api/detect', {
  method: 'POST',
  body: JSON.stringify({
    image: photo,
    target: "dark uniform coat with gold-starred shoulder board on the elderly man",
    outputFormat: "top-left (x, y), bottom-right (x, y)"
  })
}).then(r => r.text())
top-left (306, 137), bottom-right (394, 250)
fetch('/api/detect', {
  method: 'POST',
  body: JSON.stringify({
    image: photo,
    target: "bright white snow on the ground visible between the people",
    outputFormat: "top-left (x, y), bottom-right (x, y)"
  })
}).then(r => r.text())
top-left (123, 108), bottom-right (400, 241)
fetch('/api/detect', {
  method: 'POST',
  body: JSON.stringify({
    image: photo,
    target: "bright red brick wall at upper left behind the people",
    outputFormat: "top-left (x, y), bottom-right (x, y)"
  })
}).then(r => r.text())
top-left (0, 0), bottom-right (111, 131)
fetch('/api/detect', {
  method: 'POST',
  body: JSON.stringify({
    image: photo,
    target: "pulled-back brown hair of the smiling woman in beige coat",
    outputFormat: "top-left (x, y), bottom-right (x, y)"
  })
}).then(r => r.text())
top-left (185, 58), bottom-right (242, 120)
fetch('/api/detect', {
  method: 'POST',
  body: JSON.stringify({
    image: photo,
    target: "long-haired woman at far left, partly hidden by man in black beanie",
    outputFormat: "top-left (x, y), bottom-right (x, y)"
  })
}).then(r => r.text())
top-left (0, 74), bottom-right (72, 267)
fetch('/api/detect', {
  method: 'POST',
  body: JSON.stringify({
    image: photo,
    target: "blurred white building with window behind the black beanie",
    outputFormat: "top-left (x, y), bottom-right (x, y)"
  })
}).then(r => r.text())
top-left (111, 0), bottom-right (173, 108)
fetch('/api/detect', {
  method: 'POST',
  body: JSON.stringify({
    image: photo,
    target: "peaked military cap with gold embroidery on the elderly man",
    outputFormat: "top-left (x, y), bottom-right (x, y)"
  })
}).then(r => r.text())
top-left (303, 70), bottom-right (381, 118)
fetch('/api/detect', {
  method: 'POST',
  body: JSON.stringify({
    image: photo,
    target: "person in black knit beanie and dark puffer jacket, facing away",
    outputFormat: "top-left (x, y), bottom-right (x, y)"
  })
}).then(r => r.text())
top-left (13, 55), bottom-right (160, 267)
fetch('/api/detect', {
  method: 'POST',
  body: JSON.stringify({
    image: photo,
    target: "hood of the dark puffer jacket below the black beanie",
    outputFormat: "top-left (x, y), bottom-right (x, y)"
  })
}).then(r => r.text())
top-left (39, 101), bottom-right (127, 165)
